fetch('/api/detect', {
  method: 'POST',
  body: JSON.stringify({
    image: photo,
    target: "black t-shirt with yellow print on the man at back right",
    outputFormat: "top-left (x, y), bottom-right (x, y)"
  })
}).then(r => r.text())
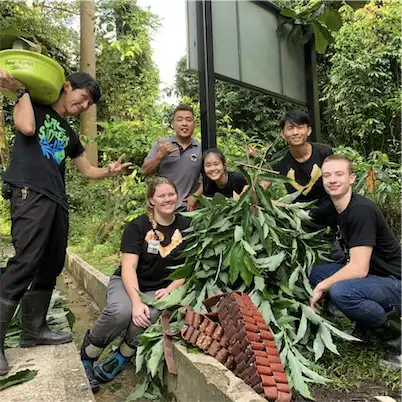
top-left (273, 142), bottom-right (333, 204)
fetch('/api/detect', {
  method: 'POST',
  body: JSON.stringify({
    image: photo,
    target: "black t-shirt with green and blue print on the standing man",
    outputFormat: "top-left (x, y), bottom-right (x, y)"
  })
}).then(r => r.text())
top-left (3, 104), bottom-right (84, 209)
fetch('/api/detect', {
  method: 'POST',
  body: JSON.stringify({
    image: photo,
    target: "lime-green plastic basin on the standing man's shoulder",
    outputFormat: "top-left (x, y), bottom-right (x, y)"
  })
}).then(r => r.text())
top-left (0, 49), bottom-right (65, 105)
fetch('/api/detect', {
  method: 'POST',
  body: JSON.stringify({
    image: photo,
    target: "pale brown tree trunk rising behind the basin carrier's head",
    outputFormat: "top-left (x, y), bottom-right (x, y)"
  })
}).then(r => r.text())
top-left (80, 0), bottom-right (98, 166)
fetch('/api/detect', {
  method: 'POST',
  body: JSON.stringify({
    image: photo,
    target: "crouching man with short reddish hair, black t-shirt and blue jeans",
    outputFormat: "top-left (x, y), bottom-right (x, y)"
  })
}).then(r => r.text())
top-left (310, 155), bottom-right (402, 368)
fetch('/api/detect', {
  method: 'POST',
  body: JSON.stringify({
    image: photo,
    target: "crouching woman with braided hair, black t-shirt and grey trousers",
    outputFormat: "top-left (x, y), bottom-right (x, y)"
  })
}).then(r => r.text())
top-left (81, 177), bottom-right (190, 392)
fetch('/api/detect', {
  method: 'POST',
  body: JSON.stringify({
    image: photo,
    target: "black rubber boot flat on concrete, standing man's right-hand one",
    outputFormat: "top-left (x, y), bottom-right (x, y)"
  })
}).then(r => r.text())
top-left (20, 290), bottom-right (73, 348)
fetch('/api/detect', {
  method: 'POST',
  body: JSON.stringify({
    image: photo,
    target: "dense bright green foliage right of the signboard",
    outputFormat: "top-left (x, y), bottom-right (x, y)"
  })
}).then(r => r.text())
top-left (322, 0), bottom-right (402, 155)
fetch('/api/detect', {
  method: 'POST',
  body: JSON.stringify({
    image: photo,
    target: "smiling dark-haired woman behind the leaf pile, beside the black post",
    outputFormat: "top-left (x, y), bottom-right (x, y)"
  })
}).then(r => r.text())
top-left (202, 148), bottom-right (247, 198)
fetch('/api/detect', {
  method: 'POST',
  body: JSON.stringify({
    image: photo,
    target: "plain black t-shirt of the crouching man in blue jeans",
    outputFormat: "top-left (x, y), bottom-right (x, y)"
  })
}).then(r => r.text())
top-left (338, 195), bottom-right (402, 279)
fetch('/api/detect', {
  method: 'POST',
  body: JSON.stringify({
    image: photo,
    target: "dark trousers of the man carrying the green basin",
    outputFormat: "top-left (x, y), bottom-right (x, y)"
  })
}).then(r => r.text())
top-left (0, 187), bottom-right (68, 301)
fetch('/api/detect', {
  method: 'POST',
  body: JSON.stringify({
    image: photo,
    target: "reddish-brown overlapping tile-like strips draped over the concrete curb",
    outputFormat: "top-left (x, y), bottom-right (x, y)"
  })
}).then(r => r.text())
top-left (181, 292), bottom-right (291, 402)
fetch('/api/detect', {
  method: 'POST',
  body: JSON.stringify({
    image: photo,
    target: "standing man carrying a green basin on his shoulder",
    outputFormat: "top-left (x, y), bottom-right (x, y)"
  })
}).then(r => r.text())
top-left (0, 70), bottom-right (130, 375)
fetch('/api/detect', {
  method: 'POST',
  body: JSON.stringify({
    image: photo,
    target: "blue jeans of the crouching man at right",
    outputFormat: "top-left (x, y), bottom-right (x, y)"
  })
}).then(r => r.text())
top-left (310, 264), bottom-right (402, 327)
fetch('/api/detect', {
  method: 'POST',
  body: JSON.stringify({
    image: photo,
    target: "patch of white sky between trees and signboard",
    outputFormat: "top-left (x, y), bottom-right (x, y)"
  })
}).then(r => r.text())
top-left (138, 0), bottom-right (187, 96)
